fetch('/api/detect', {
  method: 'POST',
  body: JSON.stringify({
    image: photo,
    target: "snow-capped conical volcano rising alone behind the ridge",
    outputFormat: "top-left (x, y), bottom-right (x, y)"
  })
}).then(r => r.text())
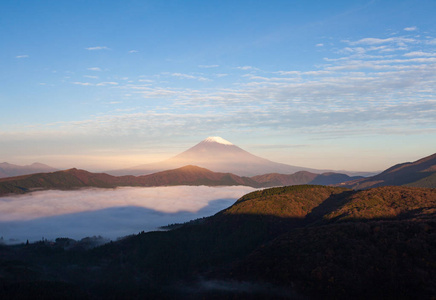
top-left (107, 136), bottom-right (322, 176)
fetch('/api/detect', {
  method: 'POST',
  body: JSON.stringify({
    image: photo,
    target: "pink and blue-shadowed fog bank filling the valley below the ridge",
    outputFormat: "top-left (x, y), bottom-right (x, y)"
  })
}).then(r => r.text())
top-left (0, 186), bottom-right (254, 243)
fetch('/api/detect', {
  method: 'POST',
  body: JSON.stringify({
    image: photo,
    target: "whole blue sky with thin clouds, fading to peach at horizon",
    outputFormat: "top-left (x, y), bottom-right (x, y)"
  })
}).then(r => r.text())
top-left (0, 0), bottom-right (436, 171)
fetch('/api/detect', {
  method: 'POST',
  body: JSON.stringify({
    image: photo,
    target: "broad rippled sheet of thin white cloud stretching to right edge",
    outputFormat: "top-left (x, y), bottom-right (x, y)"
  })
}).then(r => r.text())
top-left (60, 30), bottom-right (436, 136)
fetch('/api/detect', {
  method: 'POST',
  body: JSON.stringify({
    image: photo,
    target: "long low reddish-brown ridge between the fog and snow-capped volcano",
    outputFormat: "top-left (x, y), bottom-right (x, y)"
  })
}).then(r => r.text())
top-left (0, 166), bottom-right (360, 196)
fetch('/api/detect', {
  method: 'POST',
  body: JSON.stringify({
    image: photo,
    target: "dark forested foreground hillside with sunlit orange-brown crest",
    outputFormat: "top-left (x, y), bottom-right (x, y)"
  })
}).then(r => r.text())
top-left (0, 185), bottom-right (436, 299)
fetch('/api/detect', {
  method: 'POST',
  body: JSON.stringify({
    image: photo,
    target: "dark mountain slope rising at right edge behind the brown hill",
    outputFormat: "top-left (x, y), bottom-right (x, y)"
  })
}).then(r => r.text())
top-left (340, 153), bottom-right (436, 189)
